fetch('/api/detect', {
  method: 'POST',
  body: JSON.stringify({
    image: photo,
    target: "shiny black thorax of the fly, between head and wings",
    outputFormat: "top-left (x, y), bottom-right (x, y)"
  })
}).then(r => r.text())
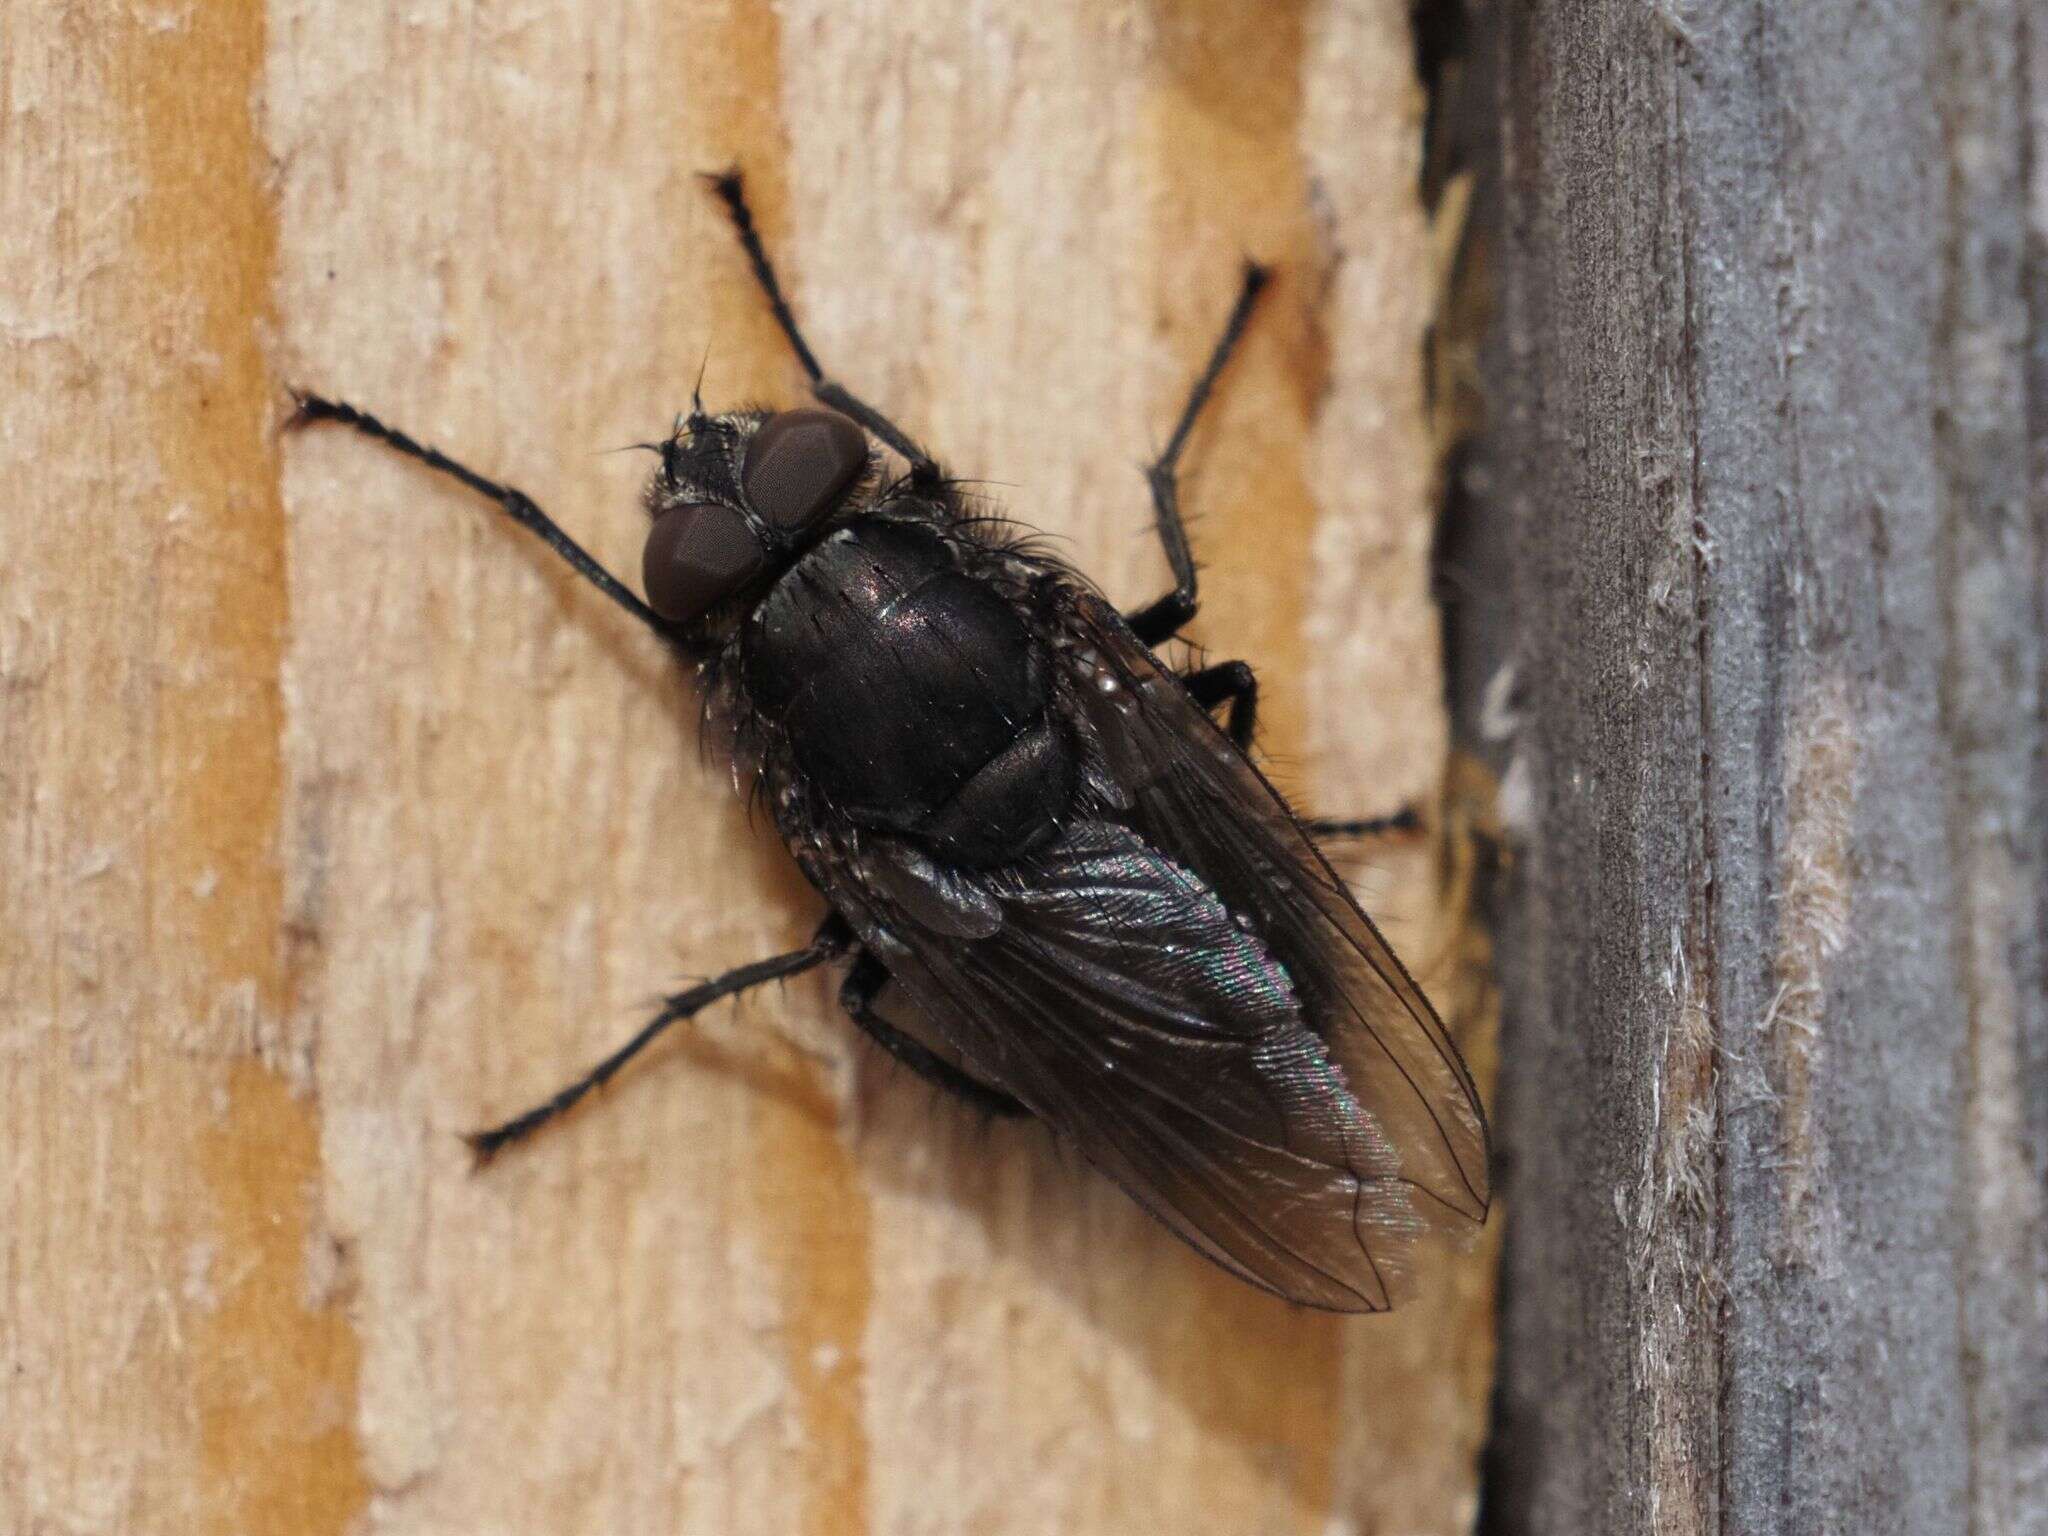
top-left (743, 522), bottom-right (1073, 866)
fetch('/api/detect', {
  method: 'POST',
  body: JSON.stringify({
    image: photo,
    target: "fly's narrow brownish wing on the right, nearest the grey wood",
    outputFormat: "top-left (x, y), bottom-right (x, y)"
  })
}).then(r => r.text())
top-left (1067, 592), bottom-right (1491, 1231)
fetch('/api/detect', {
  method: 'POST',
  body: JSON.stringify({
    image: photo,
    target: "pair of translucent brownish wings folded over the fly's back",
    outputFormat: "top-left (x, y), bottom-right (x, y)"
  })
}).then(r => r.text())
top-left (813, 592), bottom-right (1487, 1311)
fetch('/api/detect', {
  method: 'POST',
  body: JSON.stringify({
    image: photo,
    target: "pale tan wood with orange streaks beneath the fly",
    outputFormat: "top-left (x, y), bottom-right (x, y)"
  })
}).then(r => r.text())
top-left (0, 0), bottom-right (1491, 1536)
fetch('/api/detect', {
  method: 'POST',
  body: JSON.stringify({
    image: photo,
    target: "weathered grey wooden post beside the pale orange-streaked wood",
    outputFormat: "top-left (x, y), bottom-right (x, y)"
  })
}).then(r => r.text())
top-left (1489, 0), bottom-right (2048, 1536)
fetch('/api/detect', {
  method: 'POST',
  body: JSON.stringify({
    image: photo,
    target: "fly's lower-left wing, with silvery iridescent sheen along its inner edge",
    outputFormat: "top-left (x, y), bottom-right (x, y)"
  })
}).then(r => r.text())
top-left (860, 821), bottom-right (1421, 1311)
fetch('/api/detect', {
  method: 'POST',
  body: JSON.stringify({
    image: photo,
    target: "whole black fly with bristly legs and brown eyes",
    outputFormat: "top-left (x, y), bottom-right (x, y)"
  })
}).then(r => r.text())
top-left (299, 172), bottom-right (1489, 1311)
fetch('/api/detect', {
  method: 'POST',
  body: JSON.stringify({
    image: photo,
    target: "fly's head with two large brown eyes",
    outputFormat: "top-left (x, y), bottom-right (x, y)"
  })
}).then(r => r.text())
top-left (641, 406), bottom-right (874, 639)
